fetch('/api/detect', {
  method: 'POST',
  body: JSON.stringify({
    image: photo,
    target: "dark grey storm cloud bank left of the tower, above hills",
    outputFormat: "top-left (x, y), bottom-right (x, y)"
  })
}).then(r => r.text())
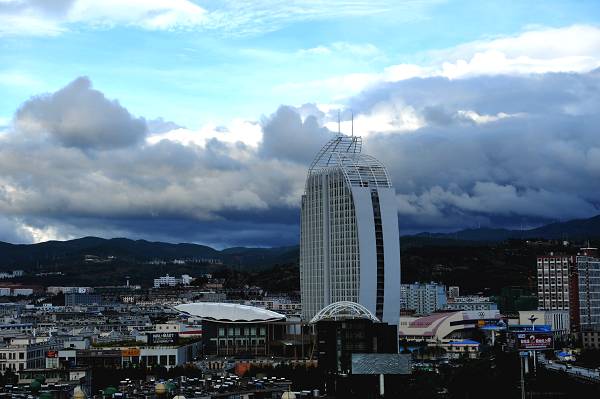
top-left (0, 78), bottom-right (305, 245)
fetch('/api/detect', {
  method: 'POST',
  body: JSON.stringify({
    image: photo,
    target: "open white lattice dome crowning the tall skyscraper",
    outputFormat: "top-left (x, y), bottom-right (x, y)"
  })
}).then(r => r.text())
top-left (308, 134), bottom-right (392, 187)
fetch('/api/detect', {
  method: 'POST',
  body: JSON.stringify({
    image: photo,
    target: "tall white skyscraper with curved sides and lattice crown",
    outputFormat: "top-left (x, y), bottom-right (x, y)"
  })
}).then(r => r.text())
top-left (300, 134), bottom-right (400, 324)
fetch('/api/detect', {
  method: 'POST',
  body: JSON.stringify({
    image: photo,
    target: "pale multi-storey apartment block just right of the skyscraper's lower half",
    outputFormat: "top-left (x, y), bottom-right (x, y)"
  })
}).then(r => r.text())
top-left (400, 282), bottom-right (447, 315)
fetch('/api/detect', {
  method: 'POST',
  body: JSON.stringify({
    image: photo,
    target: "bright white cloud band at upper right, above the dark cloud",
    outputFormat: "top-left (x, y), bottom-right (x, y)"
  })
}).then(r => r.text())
top-left (284, 25), bottom-right (600, 100)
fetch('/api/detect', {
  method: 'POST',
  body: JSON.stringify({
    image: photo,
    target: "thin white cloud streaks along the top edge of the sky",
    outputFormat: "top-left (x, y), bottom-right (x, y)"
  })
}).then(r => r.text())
top-left (0, 0), bottom-right (439, 36)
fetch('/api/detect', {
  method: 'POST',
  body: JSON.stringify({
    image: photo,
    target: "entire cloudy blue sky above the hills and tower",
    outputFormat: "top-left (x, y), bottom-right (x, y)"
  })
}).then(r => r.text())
top-left (0, 0), bottom-right (600, 248)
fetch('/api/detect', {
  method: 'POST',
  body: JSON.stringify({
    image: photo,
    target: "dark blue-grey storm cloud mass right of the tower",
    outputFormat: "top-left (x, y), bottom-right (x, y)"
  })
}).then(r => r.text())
top-left (354, 70), bottom-right (600, 230)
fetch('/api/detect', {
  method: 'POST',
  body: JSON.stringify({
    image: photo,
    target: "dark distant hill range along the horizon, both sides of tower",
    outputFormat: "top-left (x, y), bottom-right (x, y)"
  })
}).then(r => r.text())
top-left (0, 215), bottom-right (600, 269)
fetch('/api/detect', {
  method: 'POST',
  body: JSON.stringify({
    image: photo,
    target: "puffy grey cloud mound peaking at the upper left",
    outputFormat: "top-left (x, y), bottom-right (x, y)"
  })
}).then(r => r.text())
top-left (15, 77), bottom-right (146, 150)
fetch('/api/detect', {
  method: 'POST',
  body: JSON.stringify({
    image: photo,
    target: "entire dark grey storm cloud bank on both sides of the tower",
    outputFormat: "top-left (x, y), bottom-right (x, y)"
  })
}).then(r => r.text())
top-left (0, 71), bottom-right (600, 246)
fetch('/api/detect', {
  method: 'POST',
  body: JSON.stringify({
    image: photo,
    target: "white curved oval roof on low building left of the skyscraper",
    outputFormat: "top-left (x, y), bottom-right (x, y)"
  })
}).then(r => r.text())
top-left (175, 302), bottom-right (285, 323)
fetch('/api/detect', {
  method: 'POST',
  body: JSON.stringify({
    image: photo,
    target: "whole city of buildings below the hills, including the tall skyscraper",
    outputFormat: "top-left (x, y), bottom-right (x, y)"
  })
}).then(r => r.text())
top-left (0, 134), bottom-right (600, 399)
